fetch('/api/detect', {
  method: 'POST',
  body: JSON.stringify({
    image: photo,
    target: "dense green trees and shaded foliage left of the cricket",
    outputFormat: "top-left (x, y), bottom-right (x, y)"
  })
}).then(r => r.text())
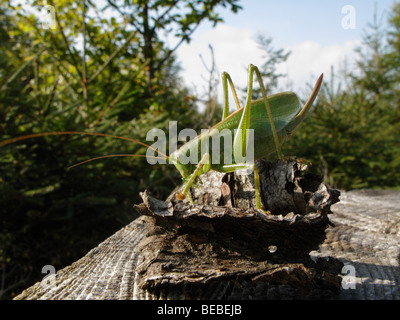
top-left (0, 0), bottom-right (238, 298)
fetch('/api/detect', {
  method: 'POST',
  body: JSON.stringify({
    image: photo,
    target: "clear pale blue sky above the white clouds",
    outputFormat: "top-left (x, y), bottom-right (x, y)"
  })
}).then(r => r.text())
top-left (211, 0), bottom-right (394, 46)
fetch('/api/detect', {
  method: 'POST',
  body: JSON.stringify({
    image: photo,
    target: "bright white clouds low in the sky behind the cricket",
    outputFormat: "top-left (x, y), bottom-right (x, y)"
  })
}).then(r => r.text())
top-left (178, 25), bottom-right (359, 110)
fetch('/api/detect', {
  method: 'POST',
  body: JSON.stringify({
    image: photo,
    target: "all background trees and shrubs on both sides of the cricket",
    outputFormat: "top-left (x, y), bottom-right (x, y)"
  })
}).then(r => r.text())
top-left (0, 0), bottom-right (400, 299)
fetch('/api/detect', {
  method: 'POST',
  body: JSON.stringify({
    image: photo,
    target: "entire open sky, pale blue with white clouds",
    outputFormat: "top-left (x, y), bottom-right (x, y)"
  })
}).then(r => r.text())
top-left (177, 0), bottom-right (395, 107)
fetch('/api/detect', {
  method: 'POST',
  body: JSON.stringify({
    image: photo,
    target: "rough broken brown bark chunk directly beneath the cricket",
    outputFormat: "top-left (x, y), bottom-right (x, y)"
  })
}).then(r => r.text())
top-left (130, 161), bottom-right (341, 299)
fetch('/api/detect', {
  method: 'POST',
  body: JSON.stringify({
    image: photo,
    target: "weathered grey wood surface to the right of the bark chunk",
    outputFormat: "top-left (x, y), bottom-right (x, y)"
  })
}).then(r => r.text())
top-left (311, 190), bottom-right (400, 300)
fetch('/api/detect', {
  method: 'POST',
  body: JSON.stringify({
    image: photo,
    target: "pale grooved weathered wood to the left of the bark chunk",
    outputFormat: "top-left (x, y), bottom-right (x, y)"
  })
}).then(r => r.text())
top-left (14, 217), bottom-right (146, 300)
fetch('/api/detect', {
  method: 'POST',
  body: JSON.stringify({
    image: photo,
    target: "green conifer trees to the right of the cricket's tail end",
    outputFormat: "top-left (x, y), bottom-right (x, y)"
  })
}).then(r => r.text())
top-left (284, 4), bottom-right (400, 189)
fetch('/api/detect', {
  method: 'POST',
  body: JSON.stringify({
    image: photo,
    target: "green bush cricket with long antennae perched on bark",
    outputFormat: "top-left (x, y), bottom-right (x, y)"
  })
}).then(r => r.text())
top-left (0, 65), bottom-right (323, 212)
